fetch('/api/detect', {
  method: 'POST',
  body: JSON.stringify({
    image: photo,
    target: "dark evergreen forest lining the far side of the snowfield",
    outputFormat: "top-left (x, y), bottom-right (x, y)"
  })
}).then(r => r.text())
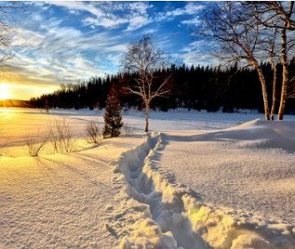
top-left (30, 58), bottom-right (295, 114)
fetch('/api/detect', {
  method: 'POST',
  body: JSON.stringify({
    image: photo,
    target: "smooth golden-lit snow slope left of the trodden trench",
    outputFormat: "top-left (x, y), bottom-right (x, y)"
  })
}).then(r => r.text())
top-left (0, 137), bottom-right (142, 249)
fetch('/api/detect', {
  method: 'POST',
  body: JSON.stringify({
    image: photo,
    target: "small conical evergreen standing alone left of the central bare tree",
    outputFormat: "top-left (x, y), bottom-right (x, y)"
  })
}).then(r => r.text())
top-left (103, 85), bottom-right (123, 138)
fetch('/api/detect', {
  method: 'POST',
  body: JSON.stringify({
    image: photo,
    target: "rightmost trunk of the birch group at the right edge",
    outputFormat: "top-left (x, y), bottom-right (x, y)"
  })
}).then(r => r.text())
top-left (278, 29), bottom-right (289, 120)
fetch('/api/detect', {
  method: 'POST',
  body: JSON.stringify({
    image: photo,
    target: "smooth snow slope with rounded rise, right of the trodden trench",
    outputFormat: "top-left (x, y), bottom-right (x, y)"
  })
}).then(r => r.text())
top-left (161, 120), bottom-right (295, 225)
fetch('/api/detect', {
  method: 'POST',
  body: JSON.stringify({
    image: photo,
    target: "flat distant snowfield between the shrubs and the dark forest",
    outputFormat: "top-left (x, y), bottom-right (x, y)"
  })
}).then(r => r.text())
top-left (0, 108), bottom-right (286, 145)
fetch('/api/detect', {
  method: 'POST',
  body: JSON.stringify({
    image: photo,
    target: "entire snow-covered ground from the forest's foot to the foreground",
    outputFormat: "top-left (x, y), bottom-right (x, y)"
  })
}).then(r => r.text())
top-left (0, 108), bottom-right (295, 249)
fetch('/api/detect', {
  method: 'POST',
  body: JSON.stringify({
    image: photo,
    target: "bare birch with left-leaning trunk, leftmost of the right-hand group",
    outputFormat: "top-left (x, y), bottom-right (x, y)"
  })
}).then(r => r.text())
top-left (200, 2), bottom-right (270, 120)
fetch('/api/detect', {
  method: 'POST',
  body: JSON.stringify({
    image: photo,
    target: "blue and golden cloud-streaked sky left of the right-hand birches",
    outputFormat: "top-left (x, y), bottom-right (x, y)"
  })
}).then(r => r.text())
top-left (0, 1), bottom-right (216, 99)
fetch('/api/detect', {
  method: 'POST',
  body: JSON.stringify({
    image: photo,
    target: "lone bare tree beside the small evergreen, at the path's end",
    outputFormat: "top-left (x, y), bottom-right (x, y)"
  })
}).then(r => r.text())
top-left (122, 35), bottom-right (171, 132)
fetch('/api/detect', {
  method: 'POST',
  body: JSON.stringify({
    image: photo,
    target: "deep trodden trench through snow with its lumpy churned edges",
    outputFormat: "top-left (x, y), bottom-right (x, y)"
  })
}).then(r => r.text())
top-left (110, 134), bottom-right (295, 249)
